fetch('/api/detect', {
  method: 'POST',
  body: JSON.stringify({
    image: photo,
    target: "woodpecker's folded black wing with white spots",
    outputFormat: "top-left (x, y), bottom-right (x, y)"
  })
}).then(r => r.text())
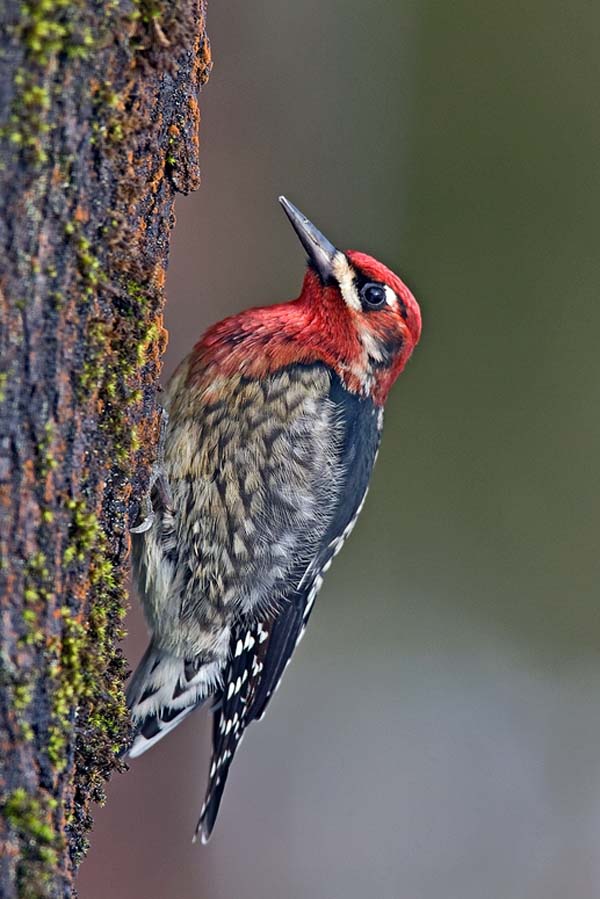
top-left (196, 372), bottom-right (381, 842)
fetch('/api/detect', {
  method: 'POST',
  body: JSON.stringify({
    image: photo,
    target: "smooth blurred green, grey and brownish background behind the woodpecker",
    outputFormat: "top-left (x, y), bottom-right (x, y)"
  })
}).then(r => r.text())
top-left (79, 0), bottom-right (600, 899)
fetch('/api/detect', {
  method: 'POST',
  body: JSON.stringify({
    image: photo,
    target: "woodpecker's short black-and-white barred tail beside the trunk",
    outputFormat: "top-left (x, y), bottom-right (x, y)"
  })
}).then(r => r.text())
top-left (126, 642), bottom-right (221, 758)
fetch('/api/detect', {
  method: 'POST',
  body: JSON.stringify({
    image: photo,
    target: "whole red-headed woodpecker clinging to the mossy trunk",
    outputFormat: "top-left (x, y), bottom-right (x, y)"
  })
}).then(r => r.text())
top-left (127, 197), bottom-right (421, 842)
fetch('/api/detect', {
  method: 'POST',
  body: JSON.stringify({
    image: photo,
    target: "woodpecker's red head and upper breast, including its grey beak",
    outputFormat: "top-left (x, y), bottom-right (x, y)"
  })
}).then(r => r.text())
top-left (190, 197), bottom-right (421, 404)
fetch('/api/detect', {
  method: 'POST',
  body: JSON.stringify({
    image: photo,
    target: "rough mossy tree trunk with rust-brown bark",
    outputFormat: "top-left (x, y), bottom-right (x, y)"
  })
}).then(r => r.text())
top-left (0, 0), bottom-right (209, 899)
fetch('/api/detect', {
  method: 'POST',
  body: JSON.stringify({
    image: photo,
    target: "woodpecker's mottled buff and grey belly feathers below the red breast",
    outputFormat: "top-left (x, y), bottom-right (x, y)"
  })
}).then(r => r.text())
top-left (136, 366), bottom-right (344, 655)
